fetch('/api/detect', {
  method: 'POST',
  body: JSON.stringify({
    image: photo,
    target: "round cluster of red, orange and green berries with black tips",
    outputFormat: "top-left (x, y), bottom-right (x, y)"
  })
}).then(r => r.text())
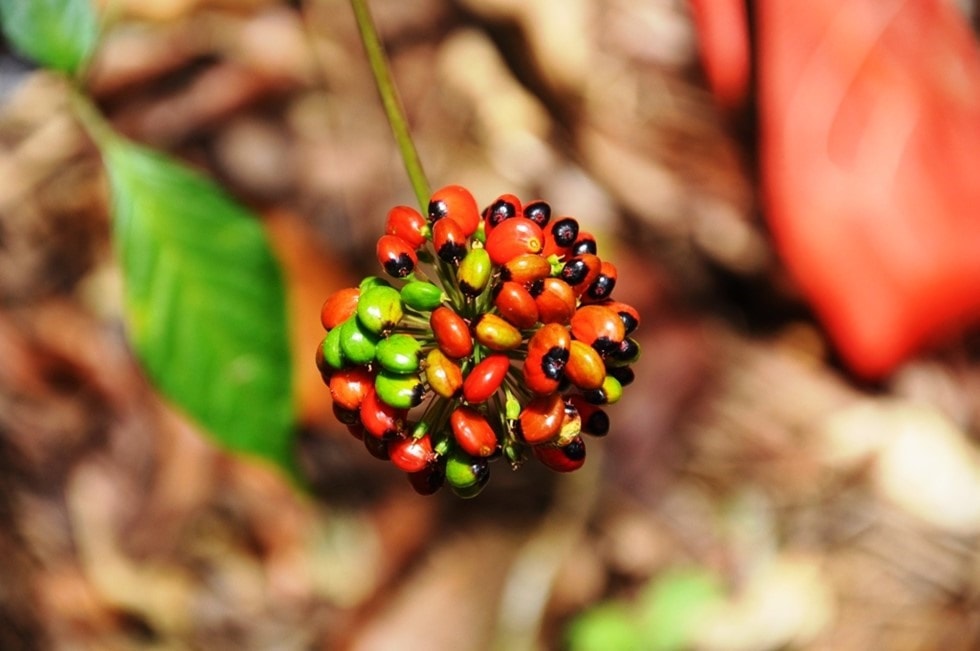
top-left (317, 185), bottom-right (640, 497)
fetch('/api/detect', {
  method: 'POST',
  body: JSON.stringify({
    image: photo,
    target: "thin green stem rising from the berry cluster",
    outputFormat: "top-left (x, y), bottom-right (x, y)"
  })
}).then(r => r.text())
top-left (350, 0), bottom-right (431, 215)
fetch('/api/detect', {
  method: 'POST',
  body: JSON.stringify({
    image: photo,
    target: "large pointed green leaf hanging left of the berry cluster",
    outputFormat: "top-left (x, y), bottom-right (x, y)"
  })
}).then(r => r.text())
top-left (102, 138), bottom-right (296, 478)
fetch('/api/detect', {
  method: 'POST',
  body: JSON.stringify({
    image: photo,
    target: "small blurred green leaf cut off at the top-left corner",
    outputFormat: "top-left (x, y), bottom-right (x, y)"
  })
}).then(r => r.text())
top-left (0, 0), bottom-right (99, 74)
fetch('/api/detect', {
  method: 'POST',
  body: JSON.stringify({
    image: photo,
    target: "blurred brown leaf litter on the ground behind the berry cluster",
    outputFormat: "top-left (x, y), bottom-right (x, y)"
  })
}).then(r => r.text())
top-left (0, 0), bottom-right (980, 651)
